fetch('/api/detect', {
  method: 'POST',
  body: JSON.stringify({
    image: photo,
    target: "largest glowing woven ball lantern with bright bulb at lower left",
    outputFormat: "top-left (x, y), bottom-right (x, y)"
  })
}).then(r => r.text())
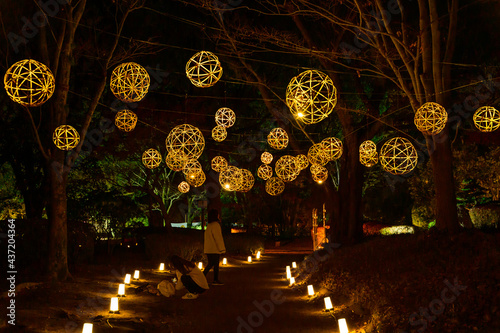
top-left (286, 70), bottom-right (337, 124)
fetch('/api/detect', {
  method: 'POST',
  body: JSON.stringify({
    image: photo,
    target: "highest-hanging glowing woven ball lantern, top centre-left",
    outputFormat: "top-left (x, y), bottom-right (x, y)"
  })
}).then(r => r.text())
top-left (186, 51), bottom-right (222, 88)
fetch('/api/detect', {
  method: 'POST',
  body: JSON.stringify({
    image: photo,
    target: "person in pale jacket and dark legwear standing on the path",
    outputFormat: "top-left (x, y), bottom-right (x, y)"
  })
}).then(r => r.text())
top-left (203, 209), bottom-right (226, 286)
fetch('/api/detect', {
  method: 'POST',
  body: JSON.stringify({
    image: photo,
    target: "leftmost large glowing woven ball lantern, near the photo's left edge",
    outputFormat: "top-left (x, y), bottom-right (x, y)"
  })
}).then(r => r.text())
top-left (3, 59), bottom-right (55, 106)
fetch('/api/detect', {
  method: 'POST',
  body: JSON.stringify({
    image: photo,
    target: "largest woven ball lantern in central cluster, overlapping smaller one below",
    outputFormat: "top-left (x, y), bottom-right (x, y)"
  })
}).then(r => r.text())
top-left (165, 124), bottom-right (205, 159)
